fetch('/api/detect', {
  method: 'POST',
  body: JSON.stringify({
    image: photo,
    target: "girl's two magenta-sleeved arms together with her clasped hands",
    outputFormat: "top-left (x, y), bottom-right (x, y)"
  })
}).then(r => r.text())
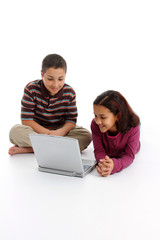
top-left (91, 120), bottom-right (140, 176)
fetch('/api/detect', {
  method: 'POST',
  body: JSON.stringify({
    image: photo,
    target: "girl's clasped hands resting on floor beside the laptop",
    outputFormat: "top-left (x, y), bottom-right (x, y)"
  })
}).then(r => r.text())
top-left (96, 156), bottom-right (114, 177)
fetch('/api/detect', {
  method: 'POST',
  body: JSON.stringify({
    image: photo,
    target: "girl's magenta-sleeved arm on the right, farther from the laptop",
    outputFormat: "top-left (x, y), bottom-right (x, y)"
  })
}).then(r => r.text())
top-left (112, 126), bottom-right (140, 174)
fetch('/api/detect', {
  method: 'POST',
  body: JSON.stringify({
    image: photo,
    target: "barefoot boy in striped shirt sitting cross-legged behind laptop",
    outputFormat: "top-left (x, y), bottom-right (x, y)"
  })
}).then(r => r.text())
top-left (9, 54), bottom-right (91, 155)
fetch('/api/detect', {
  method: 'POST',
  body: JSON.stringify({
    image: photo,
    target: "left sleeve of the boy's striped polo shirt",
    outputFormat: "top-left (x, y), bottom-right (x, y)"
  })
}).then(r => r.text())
top-left (21, 85), bottom-right (35, 120)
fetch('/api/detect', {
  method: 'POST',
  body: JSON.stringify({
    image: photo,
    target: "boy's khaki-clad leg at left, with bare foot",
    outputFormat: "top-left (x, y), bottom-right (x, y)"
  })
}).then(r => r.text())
top-left (8, 124), bottom-right (35, 155)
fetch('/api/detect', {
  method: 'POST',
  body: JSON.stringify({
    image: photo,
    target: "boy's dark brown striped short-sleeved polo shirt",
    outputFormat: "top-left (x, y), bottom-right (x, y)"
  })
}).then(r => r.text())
top-left (21, 80), bottom-right (78, 128)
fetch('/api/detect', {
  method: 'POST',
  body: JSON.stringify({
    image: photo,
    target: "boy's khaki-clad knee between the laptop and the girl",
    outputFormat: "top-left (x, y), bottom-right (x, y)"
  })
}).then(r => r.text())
top-left (66, 126), bottom-right (92, 151)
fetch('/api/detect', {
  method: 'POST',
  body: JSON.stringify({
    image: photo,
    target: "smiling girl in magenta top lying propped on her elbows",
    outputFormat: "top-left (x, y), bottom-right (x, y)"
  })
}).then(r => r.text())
top-left (91, 90), bottom-right (140, 177)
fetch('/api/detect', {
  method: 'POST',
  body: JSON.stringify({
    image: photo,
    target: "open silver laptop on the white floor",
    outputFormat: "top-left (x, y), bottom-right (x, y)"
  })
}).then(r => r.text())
top-left (29, 134), bottom-right (96, 177)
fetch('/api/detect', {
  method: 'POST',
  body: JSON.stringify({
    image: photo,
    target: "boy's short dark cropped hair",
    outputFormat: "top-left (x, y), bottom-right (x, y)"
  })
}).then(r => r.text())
top-left (42, 54), bottom-right (67, 74)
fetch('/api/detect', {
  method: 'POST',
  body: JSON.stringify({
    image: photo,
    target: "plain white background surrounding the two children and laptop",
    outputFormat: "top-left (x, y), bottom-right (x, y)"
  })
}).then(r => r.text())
top-left (0, 0), bottom-right (160, 240)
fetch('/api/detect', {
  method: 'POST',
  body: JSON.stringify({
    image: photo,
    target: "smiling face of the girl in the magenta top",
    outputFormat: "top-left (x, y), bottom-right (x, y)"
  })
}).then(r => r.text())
top-left (93, 104), bottom-right (118, 133)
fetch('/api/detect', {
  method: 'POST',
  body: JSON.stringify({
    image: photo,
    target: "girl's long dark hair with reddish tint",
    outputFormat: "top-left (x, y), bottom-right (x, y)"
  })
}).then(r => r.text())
top-left (93, 90), bottom-right (140, 133)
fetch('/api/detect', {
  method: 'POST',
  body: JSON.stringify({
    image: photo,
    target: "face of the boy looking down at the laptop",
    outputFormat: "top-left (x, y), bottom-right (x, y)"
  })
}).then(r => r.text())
top-left (41, 68), bottom-right (66, 95)
